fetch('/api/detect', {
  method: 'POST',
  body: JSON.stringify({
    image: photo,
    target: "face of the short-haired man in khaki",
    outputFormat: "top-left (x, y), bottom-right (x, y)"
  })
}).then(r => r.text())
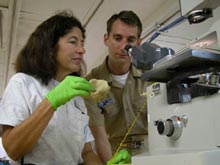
top-left (104, 19), bottom-right (141, 64)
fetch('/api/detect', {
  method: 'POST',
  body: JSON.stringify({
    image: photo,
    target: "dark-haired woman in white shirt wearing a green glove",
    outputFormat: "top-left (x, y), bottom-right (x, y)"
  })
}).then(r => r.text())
top-left (0, 12), bottom-right (101, 165)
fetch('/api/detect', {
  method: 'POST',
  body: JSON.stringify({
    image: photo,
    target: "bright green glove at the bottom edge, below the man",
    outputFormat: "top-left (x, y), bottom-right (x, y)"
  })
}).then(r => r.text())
top-left (107, 149), bottom-right (131, 165)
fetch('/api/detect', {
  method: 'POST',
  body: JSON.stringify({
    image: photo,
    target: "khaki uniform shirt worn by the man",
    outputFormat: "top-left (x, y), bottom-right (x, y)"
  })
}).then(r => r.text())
top-left (85, 58), bottom-right (149, 152)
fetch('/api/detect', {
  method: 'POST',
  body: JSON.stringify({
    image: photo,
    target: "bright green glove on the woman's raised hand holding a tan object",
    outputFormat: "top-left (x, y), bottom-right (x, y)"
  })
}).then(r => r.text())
top-left (46, 76), bottom-right (94, 110)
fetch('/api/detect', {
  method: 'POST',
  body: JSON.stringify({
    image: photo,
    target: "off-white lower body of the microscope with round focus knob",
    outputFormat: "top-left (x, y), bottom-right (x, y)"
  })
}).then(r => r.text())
top-left (132, 83), bottom-right (220, 165)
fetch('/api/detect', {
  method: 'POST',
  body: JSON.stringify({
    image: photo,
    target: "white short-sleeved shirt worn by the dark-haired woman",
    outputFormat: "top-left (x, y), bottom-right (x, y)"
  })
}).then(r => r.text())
top-left (0, 73), bottom-right (94, 165)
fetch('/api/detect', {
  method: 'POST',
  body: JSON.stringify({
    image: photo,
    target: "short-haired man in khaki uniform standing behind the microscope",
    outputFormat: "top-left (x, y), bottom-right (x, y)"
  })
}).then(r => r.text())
top-left (86, 11), bottom-right (151, 163)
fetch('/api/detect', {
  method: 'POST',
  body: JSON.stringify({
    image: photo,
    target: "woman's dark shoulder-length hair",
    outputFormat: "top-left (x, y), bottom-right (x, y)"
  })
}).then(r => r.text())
top-left (15, 11), bottom-right (85, 85)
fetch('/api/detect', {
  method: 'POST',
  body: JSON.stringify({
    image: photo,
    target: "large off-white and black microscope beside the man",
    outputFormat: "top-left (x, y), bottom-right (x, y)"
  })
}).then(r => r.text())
top-left (125, 0), bottom-right (220, 165)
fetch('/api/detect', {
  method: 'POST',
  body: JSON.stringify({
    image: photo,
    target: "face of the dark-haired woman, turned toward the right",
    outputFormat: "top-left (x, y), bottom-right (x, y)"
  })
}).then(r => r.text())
top-left (56, 27), bottom-right (85, 76)
